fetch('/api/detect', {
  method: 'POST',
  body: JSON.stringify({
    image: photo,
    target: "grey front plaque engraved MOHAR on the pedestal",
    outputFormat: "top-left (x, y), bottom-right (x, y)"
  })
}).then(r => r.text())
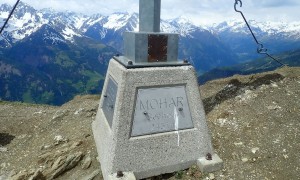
top-left (131, 86), bottom-right (194, 137)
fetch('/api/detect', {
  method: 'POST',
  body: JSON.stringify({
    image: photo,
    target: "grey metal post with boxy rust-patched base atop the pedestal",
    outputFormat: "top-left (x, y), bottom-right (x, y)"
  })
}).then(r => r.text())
top-left (121, 0), bottom-right (180, 68)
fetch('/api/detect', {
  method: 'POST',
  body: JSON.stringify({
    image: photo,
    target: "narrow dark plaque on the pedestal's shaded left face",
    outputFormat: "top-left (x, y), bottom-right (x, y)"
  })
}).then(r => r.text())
top-left (102, 77), bottom-right (118, 127)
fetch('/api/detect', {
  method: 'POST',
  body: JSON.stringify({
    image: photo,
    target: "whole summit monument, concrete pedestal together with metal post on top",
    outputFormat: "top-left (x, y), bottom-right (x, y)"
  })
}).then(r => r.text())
top-left (93, 0), bottom-right (223, 180)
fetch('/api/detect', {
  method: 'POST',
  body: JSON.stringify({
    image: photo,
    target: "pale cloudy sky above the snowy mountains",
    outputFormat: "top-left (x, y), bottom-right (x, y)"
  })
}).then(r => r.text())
top-left (0, 0), bottom-right (300, 25)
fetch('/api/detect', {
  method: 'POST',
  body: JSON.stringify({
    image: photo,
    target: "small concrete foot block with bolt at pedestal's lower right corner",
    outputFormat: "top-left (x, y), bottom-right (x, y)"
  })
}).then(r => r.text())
top-left (197, 154), bottom-right (223, 173)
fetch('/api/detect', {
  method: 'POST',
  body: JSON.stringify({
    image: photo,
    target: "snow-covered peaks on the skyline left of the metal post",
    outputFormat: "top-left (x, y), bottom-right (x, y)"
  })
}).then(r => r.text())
top-left (0, 2), bottom-right (138, 43)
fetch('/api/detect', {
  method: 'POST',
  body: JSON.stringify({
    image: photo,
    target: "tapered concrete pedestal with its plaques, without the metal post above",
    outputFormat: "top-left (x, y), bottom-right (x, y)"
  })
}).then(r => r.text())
top-left (93, 59), bottom-right (222, 179)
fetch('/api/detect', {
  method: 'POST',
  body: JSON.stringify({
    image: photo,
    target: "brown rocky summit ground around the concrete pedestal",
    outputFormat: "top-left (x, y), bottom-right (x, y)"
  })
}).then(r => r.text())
top-left (0, 67), bottom-right (300, 180)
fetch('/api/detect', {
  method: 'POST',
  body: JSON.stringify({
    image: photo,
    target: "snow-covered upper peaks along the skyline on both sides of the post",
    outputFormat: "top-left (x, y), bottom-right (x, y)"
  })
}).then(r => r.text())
top-left (0, 2), bottom-right (300, 52)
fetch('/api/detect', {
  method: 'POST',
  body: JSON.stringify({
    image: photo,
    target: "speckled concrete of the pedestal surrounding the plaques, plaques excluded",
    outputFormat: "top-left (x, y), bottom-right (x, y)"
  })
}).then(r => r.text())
top-left (93, 59), bottom-right (220, 179)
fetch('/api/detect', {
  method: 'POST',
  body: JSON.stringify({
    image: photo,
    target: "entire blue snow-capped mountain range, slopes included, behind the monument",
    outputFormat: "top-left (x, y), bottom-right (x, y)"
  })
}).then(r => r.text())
top-left (0, 2), bottom-right (300, 104)
